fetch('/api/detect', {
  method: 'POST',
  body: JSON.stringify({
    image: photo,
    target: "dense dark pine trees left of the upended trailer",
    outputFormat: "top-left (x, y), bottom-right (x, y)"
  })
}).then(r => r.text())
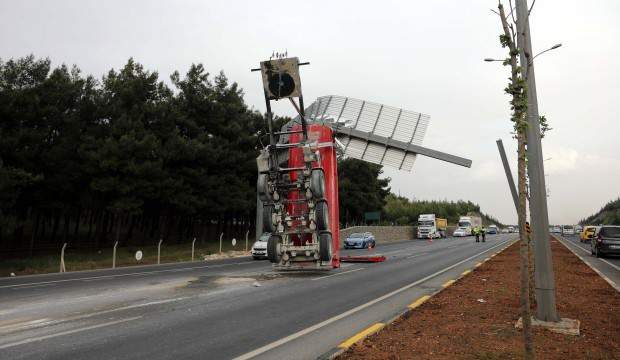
top-left (0, 56), bottom-right (264, 253)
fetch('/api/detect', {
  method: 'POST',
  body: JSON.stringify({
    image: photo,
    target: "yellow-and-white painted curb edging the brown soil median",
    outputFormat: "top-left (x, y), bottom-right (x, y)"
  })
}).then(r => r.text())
top-left (317, 239), bottom-right (519, 360)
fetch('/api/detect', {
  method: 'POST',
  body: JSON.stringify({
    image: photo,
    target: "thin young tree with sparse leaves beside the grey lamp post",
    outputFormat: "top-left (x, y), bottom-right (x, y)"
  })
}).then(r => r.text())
top-left (498, 2), bottom-right (534, 359)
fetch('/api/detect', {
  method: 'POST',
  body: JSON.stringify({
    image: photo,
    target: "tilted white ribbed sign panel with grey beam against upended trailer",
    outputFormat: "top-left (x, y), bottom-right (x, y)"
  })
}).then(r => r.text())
top-left (296, 95), bottom-right (471, 171)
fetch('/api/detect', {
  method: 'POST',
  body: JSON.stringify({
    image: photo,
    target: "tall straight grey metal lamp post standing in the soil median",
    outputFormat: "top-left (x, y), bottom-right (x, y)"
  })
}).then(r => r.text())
top-left (516, 0), bottom-right (560, 322)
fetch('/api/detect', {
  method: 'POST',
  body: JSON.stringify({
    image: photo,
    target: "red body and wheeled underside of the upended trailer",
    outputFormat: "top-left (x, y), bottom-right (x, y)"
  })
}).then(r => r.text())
top-left (261, 124), bottom-right (340, 270)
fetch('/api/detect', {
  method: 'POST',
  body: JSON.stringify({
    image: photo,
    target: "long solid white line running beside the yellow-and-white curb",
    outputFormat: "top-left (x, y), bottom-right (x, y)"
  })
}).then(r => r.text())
top-left (233, 240), bottom-right (512, 360)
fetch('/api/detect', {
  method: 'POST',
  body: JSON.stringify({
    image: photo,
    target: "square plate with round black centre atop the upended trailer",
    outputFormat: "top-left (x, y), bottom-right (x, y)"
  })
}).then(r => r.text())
top-left (260, 57), bottom-right (301, 100)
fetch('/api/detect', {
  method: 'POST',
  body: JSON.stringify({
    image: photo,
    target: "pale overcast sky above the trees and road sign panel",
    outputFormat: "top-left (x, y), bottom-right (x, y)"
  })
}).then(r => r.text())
top-left (0, 0), bottom-right (620, 223)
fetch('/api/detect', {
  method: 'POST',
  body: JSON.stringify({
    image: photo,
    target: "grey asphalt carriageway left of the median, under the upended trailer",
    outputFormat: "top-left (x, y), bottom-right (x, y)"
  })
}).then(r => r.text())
top-left (0, 234), bottom-right (515, 359)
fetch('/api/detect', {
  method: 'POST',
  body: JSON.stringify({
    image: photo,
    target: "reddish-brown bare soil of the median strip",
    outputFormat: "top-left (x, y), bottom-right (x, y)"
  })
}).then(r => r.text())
top-left (339, 240), bottom-right (620, 359)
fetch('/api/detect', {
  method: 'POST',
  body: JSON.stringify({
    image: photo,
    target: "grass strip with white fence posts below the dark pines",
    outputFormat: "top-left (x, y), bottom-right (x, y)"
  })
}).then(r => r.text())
top-left (0, 241), bottom-right (252, 277)
